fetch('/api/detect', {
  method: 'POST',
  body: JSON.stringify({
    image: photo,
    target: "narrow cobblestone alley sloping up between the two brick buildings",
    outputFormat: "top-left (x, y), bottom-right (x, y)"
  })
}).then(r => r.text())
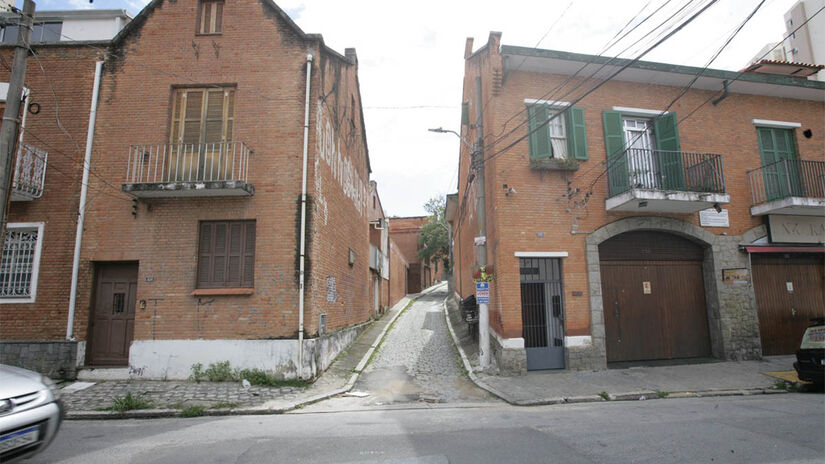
top-left (310, 286), bottom-right (497, 409)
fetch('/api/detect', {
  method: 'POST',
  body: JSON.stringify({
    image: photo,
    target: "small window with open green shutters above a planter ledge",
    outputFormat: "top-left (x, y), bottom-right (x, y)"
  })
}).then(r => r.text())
top-left (527, 103), bottom-right (587, 160)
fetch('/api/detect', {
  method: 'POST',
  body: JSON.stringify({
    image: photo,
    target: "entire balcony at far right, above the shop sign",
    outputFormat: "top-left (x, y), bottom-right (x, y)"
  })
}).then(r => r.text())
top-left (748, 159), bottom-right (825, 216)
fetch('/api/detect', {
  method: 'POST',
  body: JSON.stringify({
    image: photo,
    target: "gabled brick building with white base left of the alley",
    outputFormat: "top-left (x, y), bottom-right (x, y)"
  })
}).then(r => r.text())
top-left (1, 0), bottom-right (373, 378)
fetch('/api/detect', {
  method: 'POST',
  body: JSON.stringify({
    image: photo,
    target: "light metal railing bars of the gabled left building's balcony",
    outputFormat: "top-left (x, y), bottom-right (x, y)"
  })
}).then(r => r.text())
top-left (126, 142), bottom-right (252, 184)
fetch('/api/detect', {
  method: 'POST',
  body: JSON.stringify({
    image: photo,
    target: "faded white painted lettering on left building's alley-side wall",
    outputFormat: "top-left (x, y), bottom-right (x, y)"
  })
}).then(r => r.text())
top-left (315, 102), bottom-right (367, 216)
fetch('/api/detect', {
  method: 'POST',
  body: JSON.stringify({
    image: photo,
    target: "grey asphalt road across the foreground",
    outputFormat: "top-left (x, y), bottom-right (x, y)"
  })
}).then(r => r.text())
top-left (29, 393), bottom-right (825, 464)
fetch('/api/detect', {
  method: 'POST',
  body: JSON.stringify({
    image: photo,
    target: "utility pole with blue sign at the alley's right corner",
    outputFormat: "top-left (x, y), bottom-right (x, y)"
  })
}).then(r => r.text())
top-left (473, 77), bottom-right (490, 369)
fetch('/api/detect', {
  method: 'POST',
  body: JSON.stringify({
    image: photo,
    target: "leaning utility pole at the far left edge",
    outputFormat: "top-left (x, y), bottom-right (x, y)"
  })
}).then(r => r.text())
top-left (0, 0), bottom-right (35, 241)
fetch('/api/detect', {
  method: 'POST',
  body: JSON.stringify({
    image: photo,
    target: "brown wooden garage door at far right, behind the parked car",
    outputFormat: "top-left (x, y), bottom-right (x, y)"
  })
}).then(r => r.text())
top-left (751, 254), bottom-right (825, 356)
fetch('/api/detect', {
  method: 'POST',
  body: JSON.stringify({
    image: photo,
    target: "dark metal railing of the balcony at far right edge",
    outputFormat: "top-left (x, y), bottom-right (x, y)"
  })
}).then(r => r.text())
top-left (748, 159), bottom-right (825, 205)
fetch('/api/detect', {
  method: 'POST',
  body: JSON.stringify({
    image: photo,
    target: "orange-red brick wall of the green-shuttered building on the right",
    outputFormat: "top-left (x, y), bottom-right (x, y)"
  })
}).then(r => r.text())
top-left (459, 36), bottom-right (825, 337)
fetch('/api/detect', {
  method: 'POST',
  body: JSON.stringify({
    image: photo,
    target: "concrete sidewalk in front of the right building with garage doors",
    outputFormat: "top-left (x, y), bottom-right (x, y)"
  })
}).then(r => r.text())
top-left (444, 298), bottom-right (794, 406)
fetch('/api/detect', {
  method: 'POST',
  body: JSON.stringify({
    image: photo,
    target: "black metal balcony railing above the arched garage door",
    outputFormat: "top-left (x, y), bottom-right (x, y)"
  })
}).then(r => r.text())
top-left (607, 148), bottom-right (725, 197)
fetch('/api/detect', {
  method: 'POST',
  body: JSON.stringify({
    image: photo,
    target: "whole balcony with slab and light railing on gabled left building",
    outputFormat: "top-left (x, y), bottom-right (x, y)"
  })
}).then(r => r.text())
top-left (122, 142), bottom-right (255, 198)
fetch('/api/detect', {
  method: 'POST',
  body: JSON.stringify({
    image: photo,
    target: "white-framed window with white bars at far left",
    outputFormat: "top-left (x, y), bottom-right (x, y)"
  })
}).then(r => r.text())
top-left (0, 224), bottom-right (43, 303)
